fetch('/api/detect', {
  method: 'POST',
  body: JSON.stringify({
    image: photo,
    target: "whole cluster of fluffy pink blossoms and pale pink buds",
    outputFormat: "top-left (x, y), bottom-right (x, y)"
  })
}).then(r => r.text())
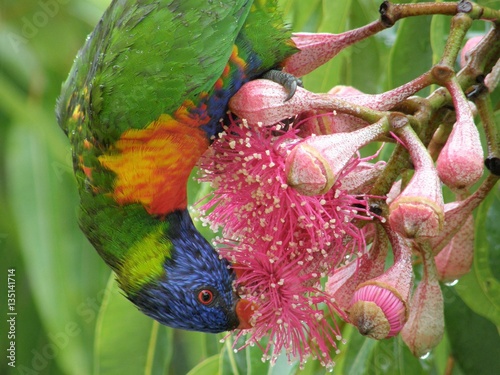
top-left (196, 34), bottom-right (496, 367)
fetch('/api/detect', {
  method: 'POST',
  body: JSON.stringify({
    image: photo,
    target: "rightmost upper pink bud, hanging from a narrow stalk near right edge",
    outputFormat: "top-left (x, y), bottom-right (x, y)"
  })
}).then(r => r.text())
top-left (437, 78), bottom-right (484, 190)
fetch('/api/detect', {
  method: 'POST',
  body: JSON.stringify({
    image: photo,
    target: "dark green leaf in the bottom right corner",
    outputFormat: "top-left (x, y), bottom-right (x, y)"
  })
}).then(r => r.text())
top-left (443, 287), bottom-right (500, 375)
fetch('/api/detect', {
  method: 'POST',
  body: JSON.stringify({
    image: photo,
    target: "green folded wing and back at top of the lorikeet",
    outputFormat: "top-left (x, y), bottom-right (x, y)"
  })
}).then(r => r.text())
top-left (59, 0), bottom-right (251, 142)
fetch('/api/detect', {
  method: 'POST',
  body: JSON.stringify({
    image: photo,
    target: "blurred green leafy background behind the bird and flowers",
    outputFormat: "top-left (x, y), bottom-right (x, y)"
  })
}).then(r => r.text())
top-left (0, 0), bottom-right (500, 375)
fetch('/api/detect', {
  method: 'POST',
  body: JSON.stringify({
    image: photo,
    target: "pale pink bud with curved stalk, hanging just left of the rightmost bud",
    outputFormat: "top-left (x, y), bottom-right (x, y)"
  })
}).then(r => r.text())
top-left (389, 127), bottom-right (444, 238)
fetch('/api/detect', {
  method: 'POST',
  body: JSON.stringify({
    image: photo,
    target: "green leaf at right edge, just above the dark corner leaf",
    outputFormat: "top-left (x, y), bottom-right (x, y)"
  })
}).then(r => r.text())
top-left (455, 187), bottom-right (500, 327)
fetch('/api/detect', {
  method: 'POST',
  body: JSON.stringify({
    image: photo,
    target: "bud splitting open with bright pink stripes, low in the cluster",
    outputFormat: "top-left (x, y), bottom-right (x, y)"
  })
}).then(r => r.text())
top-left (349, 227), bottom-right (413, 340)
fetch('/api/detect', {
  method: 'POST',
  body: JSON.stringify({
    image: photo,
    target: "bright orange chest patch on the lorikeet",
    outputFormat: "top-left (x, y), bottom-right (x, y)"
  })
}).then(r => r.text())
top-left (99, 115), bottom-right (209, 215)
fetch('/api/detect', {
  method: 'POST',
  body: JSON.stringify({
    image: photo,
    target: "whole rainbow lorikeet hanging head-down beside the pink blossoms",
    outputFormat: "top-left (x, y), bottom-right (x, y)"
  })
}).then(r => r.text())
top-left (57, 0), bottom-right (296, 333)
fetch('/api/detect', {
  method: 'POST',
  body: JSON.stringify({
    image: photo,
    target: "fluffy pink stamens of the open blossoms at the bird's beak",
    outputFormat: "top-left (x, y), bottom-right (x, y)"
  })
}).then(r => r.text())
top-left (196, 116), bottom-right (380, 366)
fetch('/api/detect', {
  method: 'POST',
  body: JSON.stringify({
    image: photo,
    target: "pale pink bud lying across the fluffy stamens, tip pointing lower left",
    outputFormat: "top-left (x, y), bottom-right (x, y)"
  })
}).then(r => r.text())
top-left (285, 121), bottom-right (388, 195)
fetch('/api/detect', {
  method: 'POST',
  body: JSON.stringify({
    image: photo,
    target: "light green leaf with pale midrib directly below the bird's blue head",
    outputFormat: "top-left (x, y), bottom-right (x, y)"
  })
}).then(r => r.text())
top-left (94, 275), bottom-right (173, 375)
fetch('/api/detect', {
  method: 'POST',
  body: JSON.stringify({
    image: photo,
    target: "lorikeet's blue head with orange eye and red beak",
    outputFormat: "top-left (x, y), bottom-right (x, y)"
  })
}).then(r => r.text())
top-left (129, 211), bottom-right (254, 333)
